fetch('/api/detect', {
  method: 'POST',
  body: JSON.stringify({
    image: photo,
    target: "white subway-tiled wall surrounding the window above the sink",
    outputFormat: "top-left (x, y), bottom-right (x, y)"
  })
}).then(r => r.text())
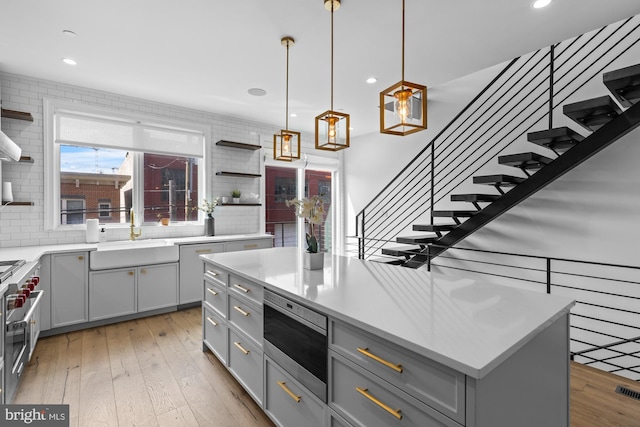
top-left (0, 72), bottom-right (328, 247)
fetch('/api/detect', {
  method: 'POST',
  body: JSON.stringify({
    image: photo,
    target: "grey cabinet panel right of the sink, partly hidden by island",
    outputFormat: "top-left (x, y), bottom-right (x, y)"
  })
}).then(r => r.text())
top-left (179, 243), bottom-right (224, 304)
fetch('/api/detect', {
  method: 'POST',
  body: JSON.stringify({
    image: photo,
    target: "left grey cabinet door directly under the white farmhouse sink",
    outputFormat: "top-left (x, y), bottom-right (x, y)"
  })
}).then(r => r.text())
top-left (89, 268), bottom-right (136, 320)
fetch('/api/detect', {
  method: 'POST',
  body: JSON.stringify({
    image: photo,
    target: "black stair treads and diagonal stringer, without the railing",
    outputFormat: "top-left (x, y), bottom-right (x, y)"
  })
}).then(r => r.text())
top-left (382, 64), bottom-right (640, 268)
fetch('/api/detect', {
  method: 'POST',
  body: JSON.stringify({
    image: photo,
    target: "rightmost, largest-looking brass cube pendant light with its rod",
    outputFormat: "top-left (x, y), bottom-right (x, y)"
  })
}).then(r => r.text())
top-left (380, 0), bottom-right (427, 136)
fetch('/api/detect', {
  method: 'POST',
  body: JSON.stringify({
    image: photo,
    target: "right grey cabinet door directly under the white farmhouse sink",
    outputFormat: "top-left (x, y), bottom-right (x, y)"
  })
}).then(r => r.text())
top-left (138, 263), bottom-right (178, 312)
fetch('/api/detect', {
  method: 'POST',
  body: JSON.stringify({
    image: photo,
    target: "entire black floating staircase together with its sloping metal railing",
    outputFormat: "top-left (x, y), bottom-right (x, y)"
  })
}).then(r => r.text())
top-left (356, 16), bottom-right (640, 268)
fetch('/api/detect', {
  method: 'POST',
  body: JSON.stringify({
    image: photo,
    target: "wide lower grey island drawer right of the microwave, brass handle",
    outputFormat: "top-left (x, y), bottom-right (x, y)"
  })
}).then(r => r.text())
top-left (329, 351), bottom-right (460, 427)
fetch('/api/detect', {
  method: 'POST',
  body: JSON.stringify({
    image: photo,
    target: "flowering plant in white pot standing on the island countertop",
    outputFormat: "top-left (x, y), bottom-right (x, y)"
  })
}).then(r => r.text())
top-left (285, 195), bottom-right (324, 270)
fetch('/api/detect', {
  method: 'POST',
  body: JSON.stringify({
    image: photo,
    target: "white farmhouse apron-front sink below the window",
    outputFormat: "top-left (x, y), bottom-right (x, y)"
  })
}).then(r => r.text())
top-left (89, 239), bottom-right (180, 270)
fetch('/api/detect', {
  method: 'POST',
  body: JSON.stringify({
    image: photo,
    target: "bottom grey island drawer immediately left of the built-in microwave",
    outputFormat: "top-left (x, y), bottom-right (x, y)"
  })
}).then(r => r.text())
top-left (229, 329), bottom-right (264, 406)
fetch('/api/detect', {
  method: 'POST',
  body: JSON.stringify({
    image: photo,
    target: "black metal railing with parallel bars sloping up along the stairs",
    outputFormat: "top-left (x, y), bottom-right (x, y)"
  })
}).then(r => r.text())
top-left (355, 16), bottom-right (640, 259)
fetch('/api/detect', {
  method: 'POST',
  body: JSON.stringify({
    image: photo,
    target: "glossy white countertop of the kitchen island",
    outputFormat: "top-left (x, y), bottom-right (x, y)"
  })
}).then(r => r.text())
top-left (201, 248), bottom-right (574, 379)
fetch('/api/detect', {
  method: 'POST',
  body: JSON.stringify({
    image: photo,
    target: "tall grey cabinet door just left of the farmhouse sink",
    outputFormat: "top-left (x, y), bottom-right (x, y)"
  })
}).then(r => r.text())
top-left (51, 252), bottom-right (89, 328)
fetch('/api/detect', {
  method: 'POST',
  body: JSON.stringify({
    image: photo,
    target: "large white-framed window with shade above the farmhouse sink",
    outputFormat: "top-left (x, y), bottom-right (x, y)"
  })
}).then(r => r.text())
top-left (45, 101), bottom-right (205, 229)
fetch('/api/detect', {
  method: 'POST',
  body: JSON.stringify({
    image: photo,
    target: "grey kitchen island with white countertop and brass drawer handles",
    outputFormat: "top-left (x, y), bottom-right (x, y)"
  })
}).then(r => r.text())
top-left (201, 248), bottom-right (574, 427)
